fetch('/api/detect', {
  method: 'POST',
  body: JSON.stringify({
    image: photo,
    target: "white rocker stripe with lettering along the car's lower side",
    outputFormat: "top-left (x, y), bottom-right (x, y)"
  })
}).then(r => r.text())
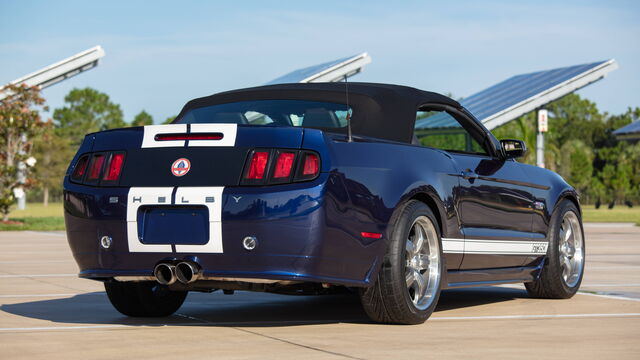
top-left (442, 238), bottom-right (549, 255)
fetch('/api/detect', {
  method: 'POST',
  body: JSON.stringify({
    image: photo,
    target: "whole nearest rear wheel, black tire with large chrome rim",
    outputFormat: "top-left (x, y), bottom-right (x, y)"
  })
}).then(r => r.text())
top-left (360, 200), bottom-right (444, 324)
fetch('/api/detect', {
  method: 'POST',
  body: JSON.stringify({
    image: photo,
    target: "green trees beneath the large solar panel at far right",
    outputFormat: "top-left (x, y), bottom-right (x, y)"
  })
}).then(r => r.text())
top-left (493, 94), bottom-right (640, 202)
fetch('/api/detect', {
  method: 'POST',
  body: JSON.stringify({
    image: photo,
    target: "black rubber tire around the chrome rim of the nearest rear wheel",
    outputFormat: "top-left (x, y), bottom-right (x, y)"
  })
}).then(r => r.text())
top-left (360, 200), bottom-right (444, 324)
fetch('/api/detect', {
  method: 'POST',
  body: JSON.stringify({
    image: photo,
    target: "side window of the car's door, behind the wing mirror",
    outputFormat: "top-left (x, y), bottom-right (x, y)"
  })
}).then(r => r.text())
top-left (414, 109), bottom-right (487, 155)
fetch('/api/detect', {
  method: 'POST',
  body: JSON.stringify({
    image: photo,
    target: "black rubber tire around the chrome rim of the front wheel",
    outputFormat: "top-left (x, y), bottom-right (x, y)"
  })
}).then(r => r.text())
top-left (524, 200), bottom-right (585, 299)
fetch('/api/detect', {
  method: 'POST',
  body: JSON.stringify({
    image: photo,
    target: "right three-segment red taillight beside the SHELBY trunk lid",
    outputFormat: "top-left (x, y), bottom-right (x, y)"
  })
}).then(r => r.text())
top-left (241, 149), bottom-right (320, 185)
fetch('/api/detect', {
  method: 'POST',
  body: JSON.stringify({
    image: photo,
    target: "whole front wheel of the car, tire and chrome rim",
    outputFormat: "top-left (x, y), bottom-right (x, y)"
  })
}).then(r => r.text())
top-left (524, 200), bottom-right (585, 299)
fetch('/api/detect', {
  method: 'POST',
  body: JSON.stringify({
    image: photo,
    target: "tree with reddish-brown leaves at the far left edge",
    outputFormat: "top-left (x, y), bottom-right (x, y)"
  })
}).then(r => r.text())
top-left (0, 84), bottom-right (51, 221)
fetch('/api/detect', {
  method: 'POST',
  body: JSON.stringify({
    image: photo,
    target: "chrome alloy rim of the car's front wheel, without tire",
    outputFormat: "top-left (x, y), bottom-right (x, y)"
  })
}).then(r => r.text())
top-left (558, 211), bottom-right (584, 287)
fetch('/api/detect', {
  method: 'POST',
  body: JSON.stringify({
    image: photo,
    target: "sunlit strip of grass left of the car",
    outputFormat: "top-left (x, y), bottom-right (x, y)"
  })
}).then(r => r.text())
top-left (0, 203), bottom-right (64, 231)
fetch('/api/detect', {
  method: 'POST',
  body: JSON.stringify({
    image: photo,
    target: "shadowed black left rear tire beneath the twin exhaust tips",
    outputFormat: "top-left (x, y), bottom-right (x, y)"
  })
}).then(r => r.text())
top-left (104, 281), bottom-right (187, 317)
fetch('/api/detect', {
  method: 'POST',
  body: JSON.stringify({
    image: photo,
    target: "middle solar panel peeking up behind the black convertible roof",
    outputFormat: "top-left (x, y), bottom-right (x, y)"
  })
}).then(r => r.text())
top-left (266, 53), bottom-right (371, 85)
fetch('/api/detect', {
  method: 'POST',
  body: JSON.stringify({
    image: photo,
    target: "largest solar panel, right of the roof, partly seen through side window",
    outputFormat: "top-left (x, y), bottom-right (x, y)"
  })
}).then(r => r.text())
top-left (416, 59), bottom-right (618, 130)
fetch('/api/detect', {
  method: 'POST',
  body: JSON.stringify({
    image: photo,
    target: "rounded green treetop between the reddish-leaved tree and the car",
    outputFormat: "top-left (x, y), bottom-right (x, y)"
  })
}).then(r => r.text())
top-left (53, 88), bottom-right (127, 147)
